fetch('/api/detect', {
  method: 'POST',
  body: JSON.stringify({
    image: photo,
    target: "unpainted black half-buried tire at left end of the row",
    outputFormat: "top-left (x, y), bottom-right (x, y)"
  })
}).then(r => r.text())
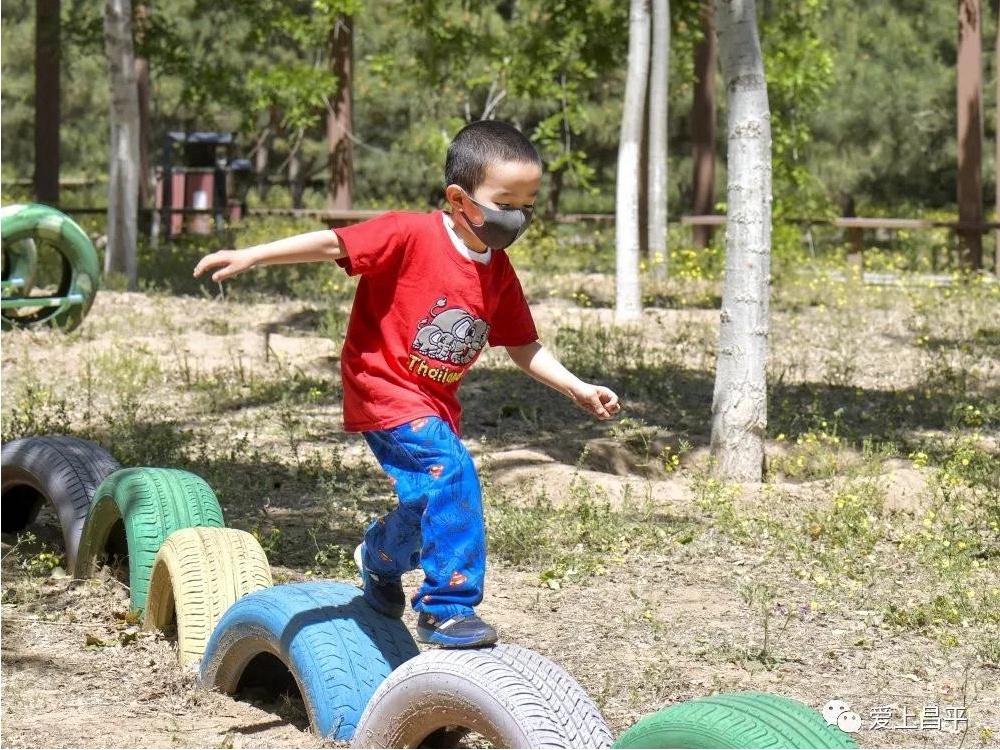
top-left (0, 435), bottom-right (120, 570)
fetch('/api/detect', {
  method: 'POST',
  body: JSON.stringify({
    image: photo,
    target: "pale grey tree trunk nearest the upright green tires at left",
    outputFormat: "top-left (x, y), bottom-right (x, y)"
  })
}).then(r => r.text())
top-left (104, 0), bottom-right (139, 290)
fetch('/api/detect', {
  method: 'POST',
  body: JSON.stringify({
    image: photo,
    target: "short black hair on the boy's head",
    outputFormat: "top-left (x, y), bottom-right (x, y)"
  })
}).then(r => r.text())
top-left (444, 120), bottom-right (542, 193)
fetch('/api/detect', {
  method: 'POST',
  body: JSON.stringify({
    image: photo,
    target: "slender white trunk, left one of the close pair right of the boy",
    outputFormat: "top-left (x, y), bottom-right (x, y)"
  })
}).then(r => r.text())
top-left (615, 0), bottom-right (649, 323)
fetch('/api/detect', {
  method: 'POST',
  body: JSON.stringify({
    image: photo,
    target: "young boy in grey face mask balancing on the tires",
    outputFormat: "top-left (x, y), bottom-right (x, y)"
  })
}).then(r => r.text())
top-left (194, 120), bottom-right (619, 648)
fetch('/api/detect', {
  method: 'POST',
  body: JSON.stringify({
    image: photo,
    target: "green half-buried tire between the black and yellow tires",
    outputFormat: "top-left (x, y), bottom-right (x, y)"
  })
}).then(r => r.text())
top-left (74, 467), bottom-right (223, 611)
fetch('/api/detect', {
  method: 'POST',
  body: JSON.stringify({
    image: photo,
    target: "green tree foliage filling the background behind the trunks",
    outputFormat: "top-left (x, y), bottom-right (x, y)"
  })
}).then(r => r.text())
top-left (2, 0), bottom-right (995, 256)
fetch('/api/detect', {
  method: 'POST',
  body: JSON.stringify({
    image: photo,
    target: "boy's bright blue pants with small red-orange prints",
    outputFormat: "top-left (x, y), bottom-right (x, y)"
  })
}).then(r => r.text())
top-left (362, 416), bottom-right (486, 619)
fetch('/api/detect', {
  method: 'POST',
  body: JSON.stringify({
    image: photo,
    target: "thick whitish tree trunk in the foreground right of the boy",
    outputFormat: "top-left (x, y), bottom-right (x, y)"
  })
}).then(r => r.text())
top-left (711, 0), bottom-right (771, 482)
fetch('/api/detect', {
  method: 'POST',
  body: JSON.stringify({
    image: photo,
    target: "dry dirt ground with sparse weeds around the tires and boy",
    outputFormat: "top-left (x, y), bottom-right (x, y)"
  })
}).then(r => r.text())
top-left (2, 277), bottom-right (1000, 747)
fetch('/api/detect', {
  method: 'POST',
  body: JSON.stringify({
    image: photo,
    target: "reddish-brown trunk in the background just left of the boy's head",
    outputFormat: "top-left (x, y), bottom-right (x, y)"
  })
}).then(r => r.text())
top-left (326, 16), bottom-right (354, 211)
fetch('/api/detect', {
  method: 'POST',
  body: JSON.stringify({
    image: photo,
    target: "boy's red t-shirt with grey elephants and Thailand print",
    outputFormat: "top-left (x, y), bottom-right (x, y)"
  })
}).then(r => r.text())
top-left (333, 210), bottom-right (538, 436)
